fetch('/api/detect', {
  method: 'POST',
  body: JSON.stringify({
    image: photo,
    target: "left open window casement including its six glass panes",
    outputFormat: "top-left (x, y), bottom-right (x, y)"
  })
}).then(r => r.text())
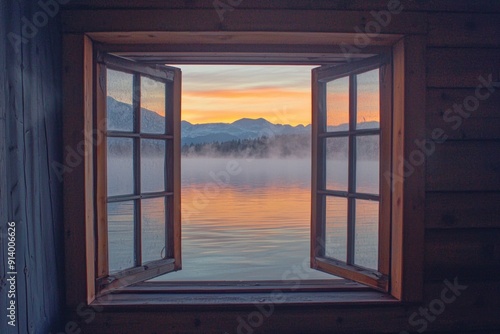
top-left (95, 54), bottom-right (181, 292)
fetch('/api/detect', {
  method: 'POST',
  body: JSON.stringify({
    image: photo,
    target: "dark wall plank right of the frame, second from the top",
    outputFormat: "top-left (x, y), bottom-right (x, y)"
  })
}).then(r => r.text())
top-left (428, 13), bottom-right (500, 48)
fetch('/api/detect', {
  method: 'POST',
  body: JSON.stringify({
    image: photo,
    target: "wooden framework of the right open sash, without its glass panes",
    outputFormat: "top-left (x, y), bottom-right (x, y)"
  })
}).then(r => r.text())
top-left (311, 55), bottom-right (392, 292)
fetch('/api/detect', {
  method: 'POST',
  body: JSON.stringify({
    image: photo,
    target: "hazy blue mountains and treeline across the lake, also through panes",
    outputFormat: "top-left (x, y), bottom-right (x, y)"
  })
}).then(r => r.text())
top-left (107, 97), bottom-right (378, 159)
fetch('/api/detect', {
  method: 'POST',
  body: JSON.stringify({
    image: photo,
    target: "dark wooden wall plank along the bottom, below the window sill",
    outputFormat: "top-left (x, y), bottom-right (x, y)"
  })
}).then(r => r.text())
top-left (70, 290), bottom-right (500, 333)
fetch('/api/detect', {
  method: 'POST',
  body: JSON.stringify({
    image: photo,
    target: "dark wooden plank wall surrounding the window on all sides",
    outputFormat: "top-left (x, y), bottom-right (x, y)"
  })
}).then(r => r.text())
top-left (0, 0), bottom-right (500, 333)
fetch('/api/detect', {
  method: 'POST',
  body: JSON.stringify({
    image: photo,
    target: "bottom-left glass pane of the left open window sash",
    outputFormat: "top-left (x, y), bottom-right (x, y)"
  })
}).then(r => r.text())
top-left (108, 201), bottom-right (135, 273)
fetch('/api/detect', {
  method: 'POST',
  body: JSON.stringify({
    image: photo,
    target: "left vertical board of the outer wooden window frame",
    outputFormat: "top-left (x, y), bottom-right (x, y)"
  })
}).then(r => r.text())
top-left (62, 35), bottom-right (95, 307)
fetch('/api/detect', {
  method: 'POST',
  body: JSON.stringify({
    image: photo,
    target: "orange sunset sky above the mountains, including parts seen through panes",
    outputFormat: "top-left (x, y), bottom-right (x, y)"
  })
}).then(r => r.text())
top-left (108, 65), bottom-right (379, 125)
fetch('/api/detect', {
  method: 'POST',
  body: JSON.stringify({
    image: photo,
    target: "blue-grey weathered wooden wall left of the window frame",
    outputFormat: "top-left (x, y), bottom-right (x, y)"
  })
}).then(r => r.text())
top-left (0, 0), bottom-right (64, 334)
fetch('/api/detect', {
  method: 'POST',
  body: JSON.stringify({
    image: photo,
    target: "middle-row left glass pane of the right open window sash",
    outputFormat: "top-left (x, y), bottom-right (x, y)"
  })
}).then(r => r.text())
top-left (325, 137), bottom-right (349, 191)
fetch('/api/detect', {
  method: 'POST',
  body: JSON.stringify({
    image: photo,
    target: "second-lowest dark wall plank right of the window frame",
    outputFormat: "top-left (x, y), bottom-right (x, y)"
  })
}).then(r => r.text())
top-left (425, 228), bottom-right (500, 281)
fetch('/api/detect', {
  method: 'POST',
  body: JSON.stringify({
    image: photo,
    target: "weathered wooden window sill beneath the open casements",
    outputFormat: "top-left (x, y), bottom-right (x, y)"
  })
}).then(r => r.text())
top-left (92, 280), bottom-right (400, 311)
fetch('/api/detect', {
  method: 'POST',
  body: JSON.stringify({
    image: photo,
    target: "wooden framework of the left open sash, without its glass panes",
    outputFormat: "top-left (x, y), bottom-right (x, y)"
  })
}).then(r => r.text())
top-left (94, 53), bottom-right (181, 293)
